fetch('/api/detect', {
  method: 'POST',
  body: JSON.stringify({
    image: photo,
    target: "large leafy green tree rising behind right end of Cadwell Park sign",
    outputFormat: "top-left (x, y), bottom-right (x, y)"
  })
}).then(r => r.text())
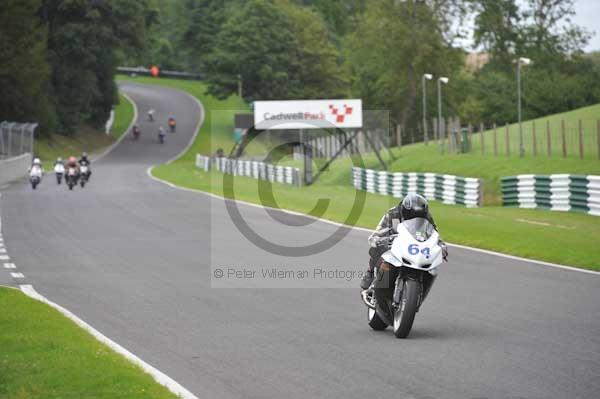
top-left (345, 0), bottom-right (462, 125)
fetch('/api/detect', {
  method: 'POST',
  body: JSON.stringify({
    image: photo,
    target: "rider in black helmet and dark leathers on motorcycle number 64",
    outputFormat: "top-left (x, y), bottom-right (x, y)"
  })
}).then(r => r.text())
top-left (360, 193), bottom-right (448, 290)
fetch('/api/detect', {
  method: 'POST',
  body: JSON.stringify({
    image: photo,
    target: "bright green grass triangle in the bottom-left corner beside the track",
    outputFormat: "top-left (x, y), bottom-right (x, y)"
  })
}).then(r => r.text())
top-left (0, 287), bottom-right (176, 399)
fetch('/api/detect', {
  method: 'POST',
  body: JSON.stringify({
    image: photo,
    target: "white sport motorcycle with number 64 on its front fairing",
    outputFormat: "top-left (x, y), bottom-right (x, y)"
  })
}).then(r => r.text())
top-left (361, 218), bottom-right (444, 338)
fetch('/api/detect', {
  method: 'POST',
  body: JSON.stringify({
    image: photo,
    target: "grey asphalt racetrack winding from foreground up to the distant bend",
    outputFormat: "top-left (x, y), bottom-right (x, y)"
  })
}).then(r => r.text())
top-left (0, 83), bottom-right (600, 399)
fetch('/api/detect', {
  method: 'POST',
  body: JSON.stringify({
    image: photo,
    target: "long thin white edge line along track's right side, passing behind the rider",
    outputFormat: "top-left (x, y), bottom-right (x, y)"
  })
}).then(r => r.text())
top-left (146, 166), bottom-right (600, 276)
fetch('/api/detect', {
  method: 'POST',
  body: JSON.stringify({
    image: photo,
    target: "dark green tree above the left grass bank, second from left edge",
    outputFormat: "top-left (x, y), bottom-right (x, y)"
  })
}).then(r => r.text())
top-left (41, 0), bottom-right (147, 134)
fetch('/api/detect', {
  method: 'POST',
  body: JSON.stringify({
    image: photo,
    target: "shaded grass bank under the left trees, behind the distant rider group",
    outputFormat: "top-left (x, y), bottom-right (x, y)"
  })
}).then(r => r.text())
top-left (34, 94), bottom-right (134, 170)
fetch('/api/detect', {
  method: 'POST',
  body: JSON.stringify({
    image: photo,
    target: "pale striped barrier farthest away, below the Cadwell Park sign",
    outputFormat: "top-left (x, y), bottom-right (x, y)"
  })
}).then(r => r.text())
top-left (196, 154), bottom-right (301, 185)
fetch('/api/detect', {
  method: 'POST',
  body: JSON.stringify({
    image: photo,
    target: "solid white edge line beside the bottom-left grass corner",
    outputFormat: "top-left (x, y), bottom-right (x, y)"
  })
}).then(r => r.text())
top-left (20, 284), bottom-right (198, 399)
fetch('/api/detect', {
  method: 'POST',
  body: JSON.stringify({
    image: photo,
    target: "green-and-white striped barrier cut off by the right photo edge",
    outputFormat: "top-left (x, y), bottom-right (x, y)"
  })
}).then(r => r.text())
top-left (502, 175), bottom-right (600, 216)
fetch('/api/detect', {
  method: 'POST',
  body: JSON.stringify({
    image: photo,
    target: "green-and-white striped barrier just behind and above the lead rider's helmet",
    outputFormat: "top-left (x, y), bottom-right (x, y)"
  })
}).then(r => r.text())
top-left (352, 168), bottom-right (483, 207)
